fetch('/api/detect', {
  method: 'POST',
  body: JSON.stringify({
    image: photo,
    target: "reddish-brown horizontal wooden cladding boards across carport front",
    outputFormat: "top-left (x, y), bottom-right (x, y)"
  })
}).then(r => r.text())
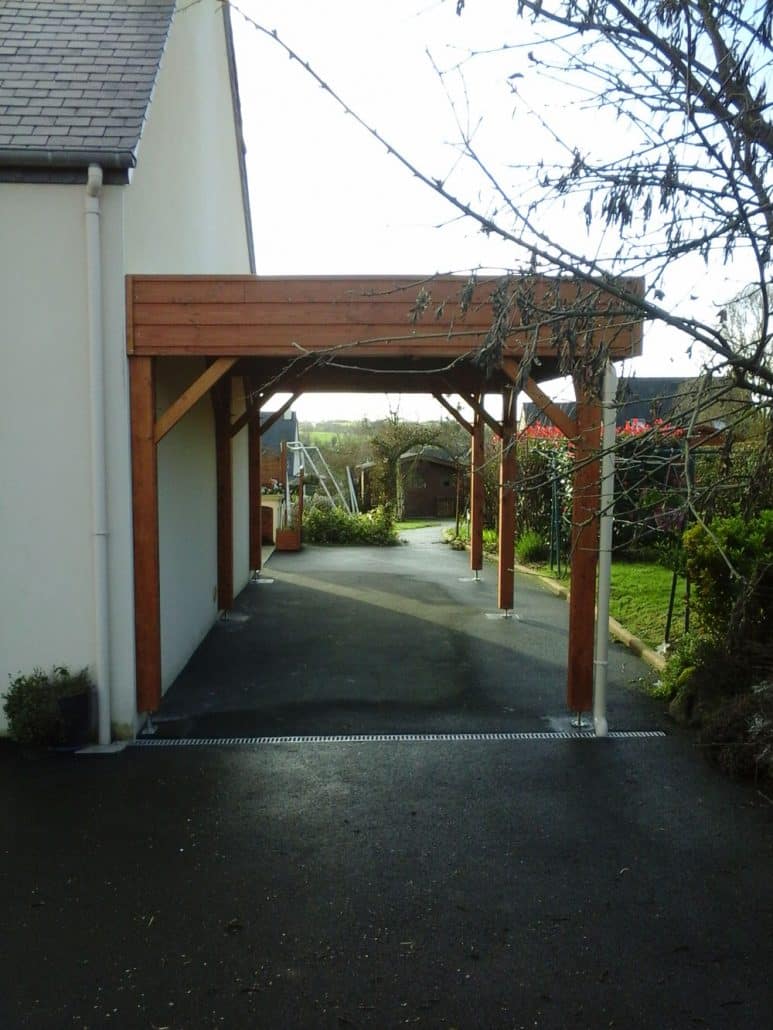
top-left (127, 276), bottom-right (643, 358)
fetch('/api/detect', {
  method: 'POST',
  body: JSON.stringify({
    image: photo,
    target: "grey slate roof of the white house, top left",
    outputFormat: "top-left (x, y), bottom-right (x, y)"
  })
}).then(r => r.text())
top-left (0, 0), bottom-right (174, 177)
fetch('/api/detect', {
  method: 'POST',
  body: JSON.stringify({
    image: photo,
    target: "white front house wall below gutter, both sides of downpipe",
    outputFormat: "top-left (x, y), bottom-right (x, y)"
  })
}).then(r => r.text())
top-left (0, 184), bottom-right (135, 734)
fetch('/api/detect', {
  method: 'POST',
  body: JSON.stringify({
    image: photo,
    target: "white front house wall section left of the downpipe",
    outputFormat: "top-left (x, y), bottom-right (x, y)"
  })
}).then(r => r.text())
top-left (0, 184), bottom-right (94, 725)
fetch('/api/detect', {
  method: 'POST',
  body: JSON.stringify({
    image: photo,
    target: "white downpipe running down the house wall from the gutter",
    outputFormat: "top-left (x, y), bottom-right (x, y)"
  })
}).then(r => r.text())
top-left (85, 165), bottom-right (112, 747)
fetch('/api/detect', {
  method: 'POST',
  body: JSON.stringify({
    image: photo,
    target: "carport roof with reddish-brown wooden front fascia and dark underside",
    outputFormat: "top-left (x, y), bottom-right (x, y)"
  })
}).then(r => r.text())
top-left (127, 276), bottom-right (642, 393)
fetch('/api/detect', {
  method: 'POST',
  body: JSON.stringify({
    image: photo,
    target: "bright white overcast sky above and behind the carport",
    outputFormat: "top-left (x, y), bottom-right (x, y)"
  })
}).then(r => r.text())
top-left (233, 0), bottom-right (721, 419)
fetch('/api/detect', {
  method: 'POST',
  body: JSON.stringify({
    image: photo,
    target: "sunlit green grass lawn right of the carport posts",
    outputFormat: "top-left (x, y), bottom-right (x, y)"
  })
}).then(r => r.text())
top-left (535, 561), bottom-right (684, 649)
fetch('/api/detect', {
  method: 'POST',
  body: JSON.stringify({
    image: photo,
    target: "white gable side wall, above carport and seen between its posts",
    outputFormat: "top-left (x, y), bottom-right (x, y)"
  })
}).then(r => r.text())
top-left (124, 0), bottom-right (249, 689)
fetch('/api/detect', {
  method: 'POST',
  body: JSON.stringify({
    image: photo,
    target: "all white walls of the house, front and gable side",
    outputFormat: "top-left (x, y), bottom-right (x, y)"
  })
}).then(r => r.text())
top-left (0, 0), bottom-right (249, 733)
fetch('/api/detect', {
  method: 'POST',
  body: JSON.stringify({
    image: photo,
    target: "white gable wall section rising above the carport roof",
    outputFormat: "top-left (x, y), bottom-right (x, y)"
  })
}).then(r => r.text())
top-left (126, 0), bottom-right (249, 275)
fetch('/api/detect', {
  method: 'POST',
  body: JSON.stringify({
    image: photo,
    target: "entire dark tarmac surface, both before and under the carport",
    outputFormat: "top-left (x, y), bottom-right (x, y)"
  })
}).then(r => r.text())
top-left (0, 531), bottom-right (773, 1030)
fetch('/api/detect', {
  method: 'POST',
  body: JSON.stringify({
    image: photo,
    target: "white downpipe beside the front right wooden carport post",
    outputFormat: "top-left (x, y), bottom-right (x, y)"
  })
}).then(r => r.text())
top-left (594, 362), bottom-right (617, 736)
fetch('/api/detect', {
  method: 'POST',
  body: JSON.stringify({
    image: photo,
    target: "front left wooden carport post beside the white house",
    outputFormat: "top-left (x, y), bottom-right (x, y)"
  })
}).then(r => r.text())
top-left (129, 357), bottom-right (161, 712)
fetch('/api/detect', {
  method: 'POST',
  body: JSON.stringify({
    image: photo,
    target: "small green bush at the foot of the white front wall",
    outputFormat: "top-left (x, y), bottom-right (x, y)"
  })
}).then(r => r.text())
top-left (3, 665), bottom-right (92, 745)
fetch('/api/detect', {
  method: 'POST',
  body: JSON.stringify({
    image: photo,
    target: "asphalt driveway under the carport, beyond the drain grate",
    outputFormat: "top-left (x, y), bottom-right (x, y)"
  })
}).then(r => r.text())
top-left (149, 526), bottom-right (663, 737)
